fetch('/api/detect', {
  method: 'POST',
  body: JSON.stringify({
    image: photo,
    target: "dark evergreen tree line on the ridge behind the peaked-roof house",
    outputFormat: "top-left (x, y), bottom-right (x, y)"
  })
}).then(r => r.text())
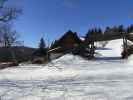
top-left (51, 25), bottom-right (133, 49)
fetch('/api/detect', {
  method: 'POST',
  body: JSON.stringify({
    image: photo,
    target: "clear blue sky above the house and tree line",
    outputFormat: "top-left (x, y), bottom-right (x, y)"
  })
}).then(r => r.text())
top-left (9, 0), bottom-right (133, 47)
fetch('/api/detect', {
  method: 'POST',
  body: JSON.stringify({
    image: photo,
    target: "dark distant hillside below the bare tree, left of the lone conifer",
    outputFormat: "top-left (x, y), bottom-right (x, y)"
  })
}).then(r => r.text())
top-left (0, 46), bottom-right (36, 62)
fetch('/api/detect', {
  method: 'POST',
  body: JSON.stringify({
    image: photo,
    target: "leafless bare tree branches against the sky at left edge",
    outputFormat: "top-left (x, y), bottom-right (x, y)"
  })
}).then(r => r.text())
top-left (0, 0), bottom-right (21, 47)
